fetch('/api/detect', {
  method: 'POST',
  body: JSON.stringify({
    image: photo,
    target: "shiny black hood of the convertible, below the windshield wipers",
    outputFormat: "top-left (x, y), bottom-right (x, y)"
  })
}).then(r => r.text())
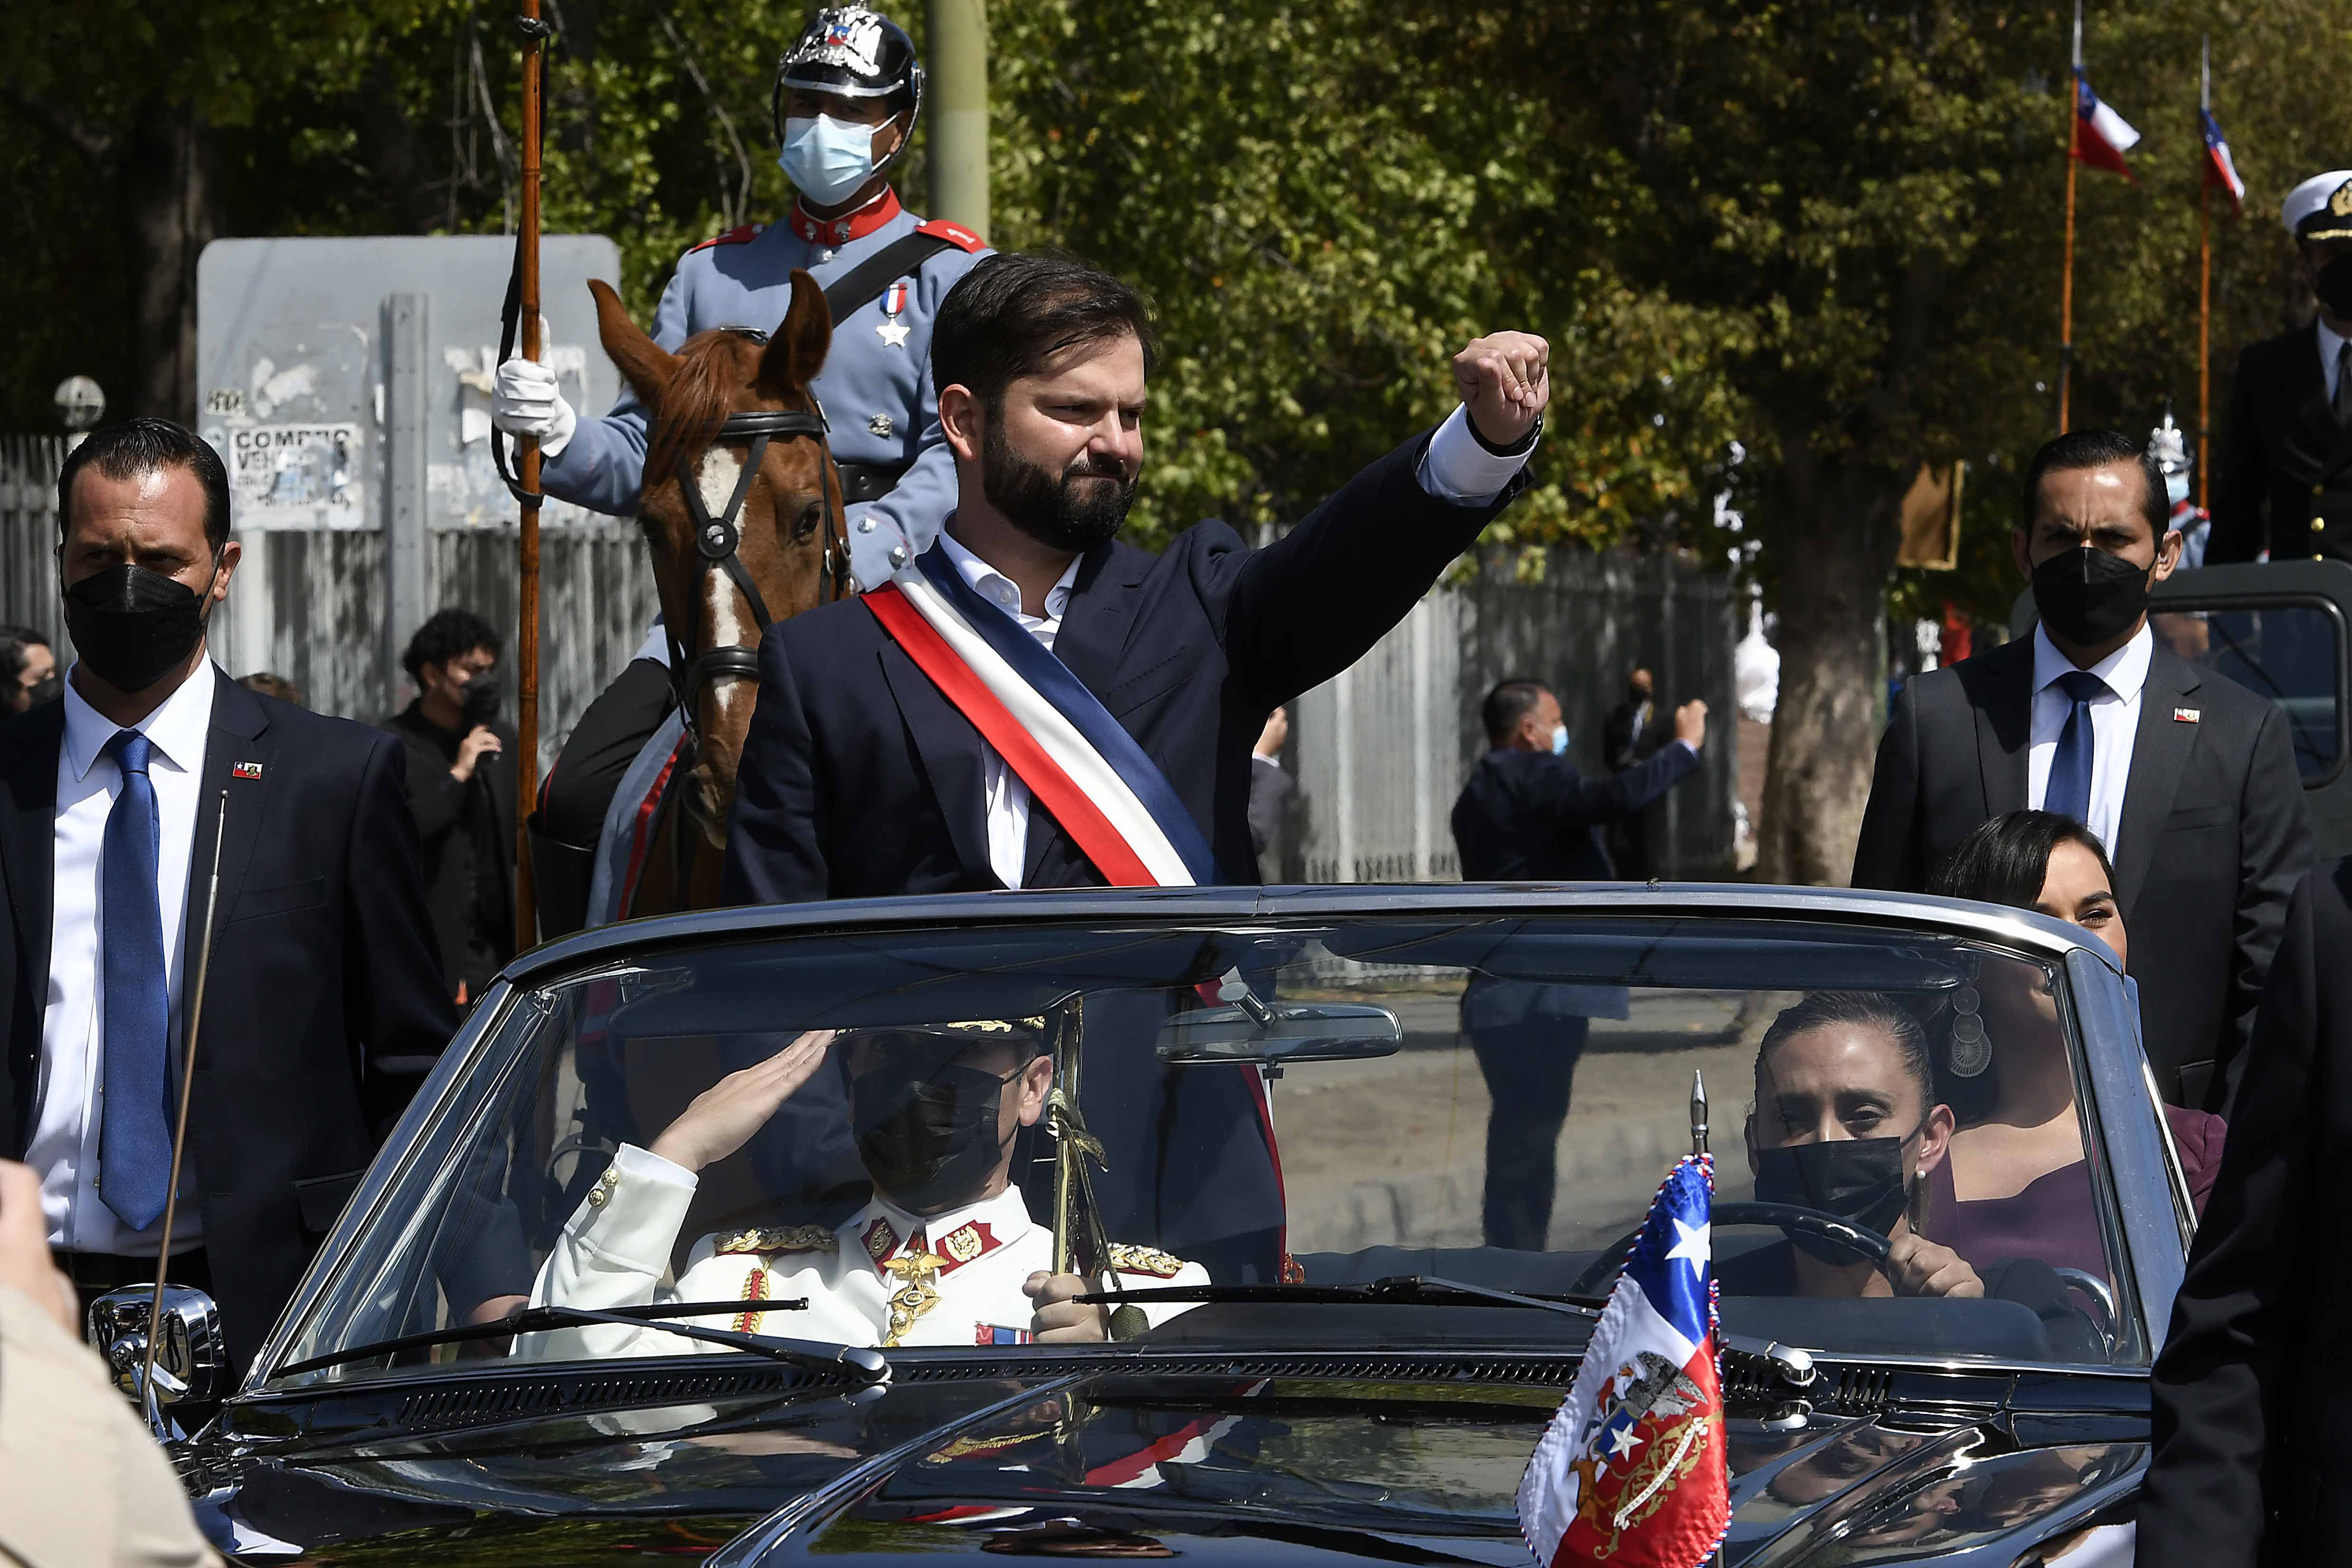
top-left (193, 1368), bottom-right (2147, 1568)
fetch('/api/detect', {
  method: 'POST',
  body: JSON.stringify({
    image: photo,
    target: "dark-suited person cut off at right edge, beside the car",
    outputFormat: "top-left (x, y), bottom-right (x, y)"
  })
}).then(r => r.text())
top-left (2138, 860), bottom-right (2352, 1568)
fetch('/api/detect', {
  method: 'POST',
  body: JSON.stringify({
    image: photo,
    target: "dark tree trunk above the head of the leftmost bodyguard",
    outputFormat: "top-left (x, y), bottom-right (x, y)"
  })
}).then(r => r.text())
top-left (118, 96), bottom-right (214, 423)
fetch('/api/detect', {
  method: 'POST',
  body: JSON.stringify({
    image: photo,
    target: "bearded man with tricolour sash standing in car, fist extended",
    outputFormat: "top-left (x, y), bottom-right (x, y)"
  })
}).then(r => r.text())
top-left (725, 254), bottom-right (1550, 1279)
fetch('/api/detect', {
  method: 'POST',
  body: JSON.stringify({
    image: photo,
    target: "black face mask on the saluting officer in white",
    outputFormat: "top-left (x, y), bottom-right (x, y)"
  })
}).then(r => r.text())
top-left (849, 1067), bottom-right (1021, 1213)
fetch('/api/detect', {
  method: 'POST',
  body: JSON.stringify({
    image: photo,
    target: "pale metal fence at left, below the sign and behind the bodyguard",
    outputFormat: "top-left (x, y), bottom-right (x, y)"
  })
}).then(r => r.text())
top-left (0, 435), bottom-right (659, 762)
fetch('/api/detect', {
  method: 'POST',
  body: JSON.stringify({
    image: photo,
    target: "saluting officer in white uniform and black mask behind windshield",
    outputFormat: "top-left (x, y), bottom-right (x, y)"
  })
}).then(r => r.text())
top-left (515, 1018), bottom-right (1209, 1359)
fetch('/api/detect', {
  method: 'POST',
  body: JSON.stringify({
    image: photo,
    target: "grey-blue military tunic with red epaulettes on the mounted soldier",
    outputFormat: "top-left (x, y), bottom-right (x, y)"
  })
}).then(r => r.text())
top-left (541, 193), bottom-right (990, 585)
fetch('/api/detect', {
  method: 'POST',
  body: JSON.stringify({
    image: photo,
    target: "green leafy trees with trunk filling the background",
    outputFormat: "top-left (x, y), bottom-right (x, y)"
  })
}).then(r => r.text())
top-left (0, 0), bottom-right (2352, 881)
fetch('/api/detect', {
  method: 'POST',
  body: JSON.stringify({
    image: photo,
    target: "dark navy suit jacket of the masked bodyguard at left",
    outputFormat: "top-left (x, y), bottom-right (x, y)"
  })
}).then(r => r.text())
top-left (0, 672), bottom-right (456, 1373)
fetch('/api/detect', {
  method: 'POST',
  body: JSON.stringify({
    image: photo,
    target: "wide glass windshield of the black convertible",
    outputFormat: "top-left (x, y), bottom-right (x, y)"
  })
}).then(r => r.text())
top-left (273, 915), bottom-right (2150, 1387)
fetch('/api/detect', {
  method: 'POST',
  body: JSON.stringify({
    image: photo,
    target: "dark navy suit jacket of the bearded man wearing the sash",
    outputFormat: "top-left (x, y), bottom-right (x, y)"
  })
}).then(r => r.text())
top-left (722, 435), bottom-right (1524, 903)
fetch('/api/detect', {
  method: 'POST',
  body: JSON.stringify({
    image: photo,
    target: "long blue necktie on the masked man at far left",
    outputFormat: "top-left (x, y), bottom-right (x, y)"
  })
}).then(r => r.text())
top-left (99, 729), bottom-right (172, 1230)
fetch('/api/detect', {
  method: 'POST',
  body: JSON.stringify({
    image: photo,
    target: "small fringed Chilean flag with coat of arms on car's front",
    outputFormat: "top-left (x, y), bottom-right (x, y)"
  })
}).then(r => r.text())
top-left (1520, 1154), bottom-right (1731, 1568)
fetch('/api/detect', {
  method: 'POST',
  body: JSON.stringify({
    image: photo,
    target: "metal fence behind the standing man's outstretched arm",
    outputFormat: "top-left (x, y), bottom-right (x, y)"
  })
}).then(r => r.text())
top-left (1263, 550), bottom-right (1738, 881)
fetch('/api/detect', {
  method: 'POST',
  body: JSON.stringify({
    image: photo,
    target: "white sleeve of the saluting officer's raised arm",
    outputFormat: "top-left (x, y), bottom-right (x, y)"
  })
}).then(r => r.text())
top-left (515, 1142), bottom-right (706, 1361)
